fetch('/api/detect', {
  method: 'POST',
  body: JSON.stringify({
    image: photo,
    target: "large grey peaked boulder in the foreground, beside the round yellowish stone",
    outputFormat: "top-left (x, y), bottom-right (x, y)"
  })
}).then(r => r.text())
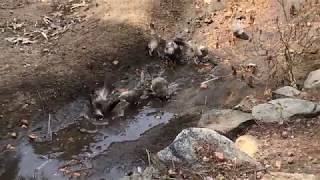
top-left (157, 128), bottom-right (259, 167)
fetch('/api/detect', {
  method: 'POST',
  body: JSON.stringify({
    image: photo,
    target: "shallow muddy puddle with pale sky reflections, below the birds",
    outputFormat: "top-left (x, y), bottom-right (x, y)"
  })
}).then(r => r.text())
top-left (2, 95), bottom-right (180, 180)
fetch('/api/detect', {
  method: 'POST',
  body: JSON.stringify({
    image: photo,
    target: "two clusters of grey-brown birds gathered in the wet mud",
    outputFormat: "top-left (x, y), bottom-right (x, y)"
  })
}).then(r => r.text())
top-left (91, 24), bottom-right (212, 119)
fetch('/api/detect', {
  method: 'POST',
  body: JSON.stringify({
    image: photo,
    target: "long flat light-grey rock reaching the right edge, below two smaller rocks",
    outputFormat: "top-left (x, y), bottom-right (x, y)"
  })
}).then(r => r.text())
top-left (252, 98), bottom-right (320, 122)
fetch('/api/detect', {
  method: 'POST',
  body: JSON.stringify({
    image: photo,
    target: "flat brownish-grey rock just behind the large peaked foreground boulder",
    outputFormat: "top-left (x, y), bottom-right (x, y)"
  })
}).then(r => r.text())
top-left (198, 109), bottom-right (253, 133)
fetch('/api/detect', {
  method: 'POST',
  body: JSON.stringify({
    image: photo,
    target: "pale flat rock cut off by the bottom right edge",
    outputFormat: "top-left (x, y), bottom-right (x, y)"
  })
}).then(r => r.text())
top-left (262, 172), bottom-right (319, 180)
